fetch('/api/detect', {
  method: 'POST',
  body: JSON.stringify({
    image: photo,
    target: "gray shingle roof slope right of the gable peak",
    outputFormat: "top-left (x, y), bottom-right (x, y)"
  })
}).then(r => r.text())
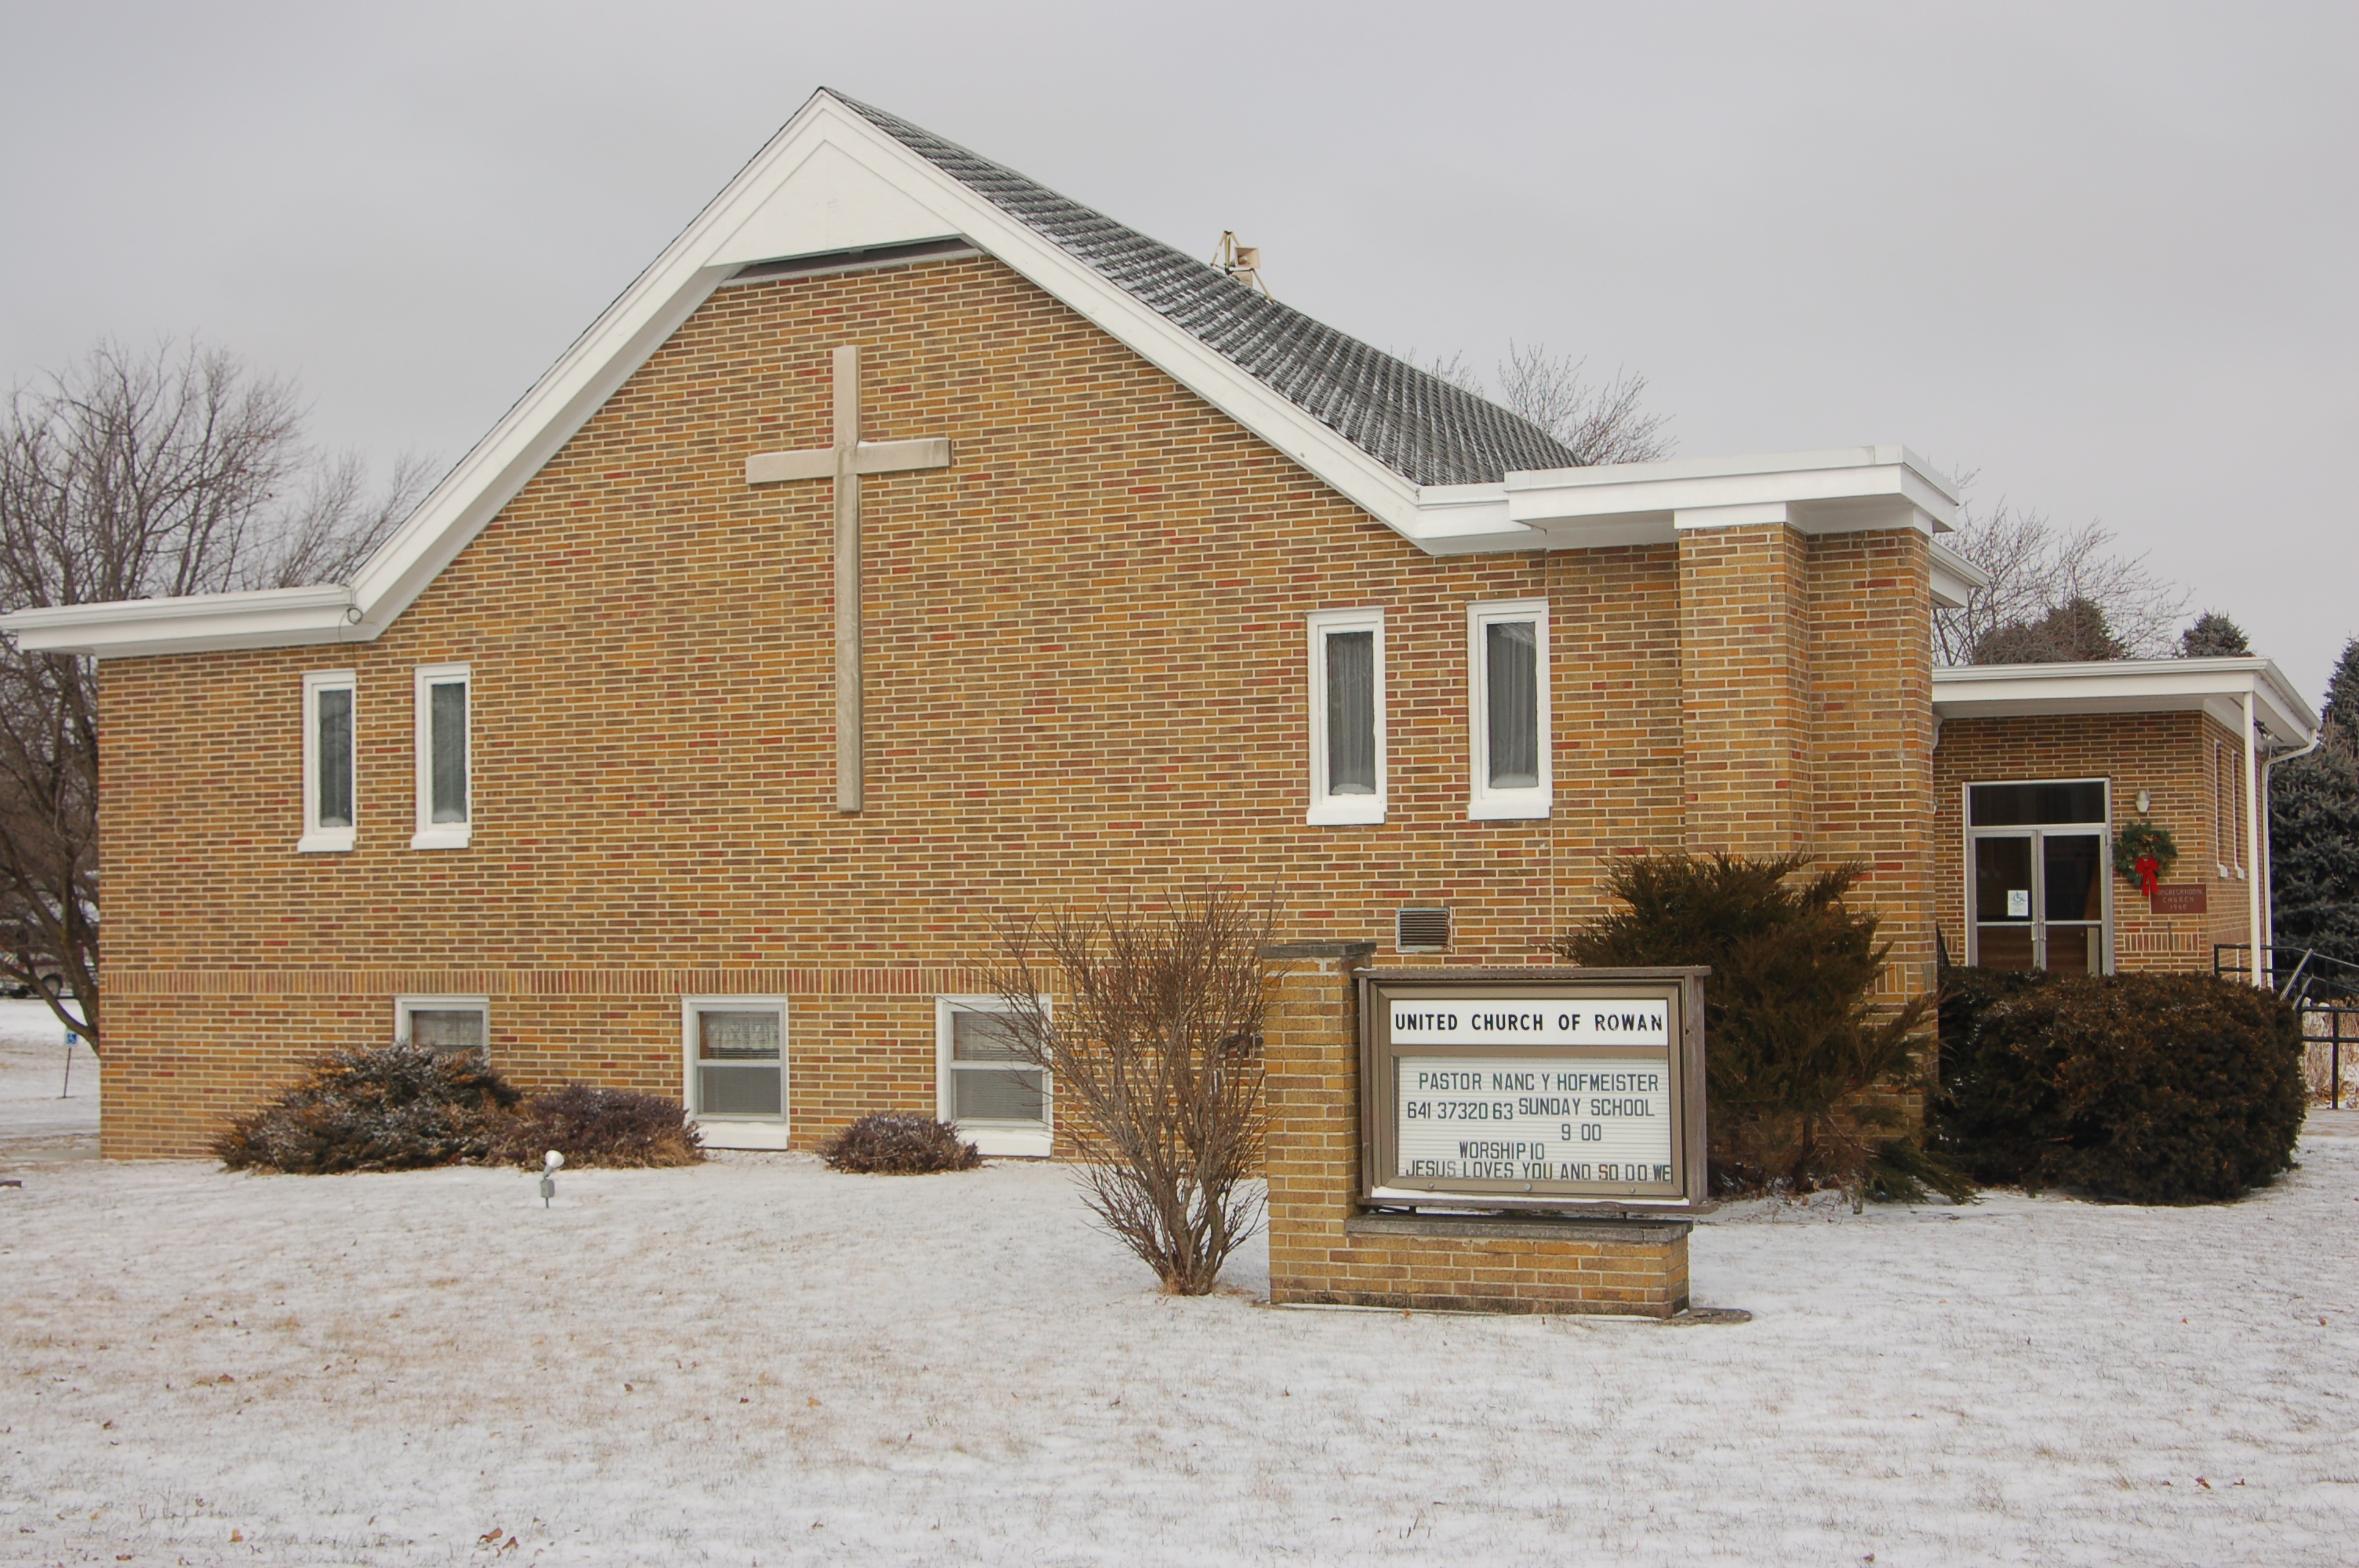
top-left (831, 89), bottom-right (1576, 484)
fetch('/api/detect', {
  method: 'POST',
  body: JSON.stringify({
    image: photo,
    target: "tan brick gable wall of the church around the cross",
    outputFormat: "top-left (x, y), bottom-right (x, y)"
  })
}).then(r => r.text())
top-left (101, 260), bottom-right (1930, 1156)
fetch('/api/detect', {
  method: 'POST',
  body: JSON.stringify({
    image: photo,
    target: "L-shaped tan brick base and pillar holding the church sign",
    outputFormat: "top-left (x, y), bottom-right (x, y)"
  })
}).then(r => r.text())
top-left (1262, 943), bottom-right (1687, 1318)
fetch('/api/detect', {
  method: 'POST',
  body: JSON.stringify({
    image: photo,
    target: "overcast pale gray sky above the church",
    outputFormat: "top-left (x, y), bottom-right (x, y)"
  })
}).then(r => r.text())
top-left (0, 0), bottom-right (2359, 702)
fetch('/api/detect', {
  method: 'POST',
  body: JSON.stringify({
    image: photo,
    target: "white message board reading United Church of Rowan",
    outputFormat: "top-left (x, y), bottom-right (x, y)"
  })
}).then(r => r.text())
top-left (1392, 997), bottom-right (1675, 1184)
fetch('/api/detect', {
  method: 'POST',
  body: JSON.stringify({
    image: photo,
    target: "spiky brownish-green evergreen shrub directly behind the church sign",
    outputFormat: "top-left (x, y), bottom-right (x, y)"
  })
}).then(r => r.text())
top-left (1554, 856), bottom-right (1970, 1200)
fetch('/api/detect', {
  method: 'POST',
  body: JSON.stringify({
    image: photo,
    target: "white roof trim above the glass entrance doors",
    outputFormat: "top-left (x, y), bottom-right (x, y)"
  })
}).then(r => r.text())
top-left (1932, 658), bottom-right (2319, 747)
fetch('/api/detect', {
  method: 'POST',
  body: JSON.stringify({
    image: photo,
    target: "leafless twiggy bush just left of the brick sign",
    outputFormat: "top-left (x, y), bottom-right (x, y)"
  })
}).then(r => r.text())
top-left (990, 891), bottom-right (1274, 1297)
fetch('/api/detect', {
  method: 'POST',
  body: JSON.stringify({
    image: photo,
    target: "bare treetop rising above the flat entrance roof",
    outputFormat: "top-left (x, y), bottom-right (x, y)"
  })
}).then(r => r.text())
top-left (1932, 477), bottom-right (2186, 665)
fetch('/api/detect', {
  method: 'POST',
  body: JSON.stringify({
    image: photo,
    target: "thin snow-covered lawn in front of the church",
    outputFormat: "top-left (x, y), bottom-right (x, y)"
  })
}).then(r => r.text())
top-left (0, 1028), bottom-right (2359, 1568)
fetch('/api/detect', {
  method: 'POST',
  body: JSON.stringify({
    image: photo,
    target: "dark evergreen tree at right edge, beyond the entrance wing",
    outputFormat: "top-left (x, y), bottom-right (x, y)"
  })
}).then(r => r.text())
top-left (2270, 637), bottom-right (2359, 981)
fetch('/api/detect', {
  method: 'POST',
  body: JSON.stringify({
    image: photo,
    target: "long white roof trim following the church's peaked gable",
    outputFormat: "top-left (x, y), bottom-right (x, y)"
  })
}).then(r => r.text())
top-left (0, 92), bottom-right (1958, 658)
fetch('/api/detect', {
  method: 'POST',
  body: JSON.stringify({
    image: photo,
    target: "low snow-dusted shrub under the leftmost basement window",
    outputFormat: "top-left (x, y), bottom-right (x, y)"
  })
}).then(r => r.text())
top-left (213, 1042), bottom-right (522, 1177)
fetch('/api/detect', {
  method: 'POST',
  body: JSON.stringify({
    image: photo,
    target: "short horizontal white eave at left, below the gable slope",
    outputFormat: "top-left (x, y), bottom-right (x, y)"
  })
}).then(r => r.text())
top-left (0, 583), bottom-right (370, 658)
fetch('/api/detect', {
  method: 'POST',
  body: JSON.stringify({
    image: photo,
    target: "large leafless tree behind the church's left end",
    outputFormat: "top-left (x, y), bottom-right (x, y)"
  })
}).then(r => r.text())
top-left (0, 342), bottom-right (424, 1049)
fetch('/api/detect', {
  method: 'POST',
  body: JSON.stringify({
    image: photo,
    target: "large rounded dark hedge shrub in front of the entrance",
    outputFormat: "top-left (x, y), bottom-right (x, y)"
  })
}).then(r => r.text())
top-left (1932, 969), bottom-right (2305, 1203)
